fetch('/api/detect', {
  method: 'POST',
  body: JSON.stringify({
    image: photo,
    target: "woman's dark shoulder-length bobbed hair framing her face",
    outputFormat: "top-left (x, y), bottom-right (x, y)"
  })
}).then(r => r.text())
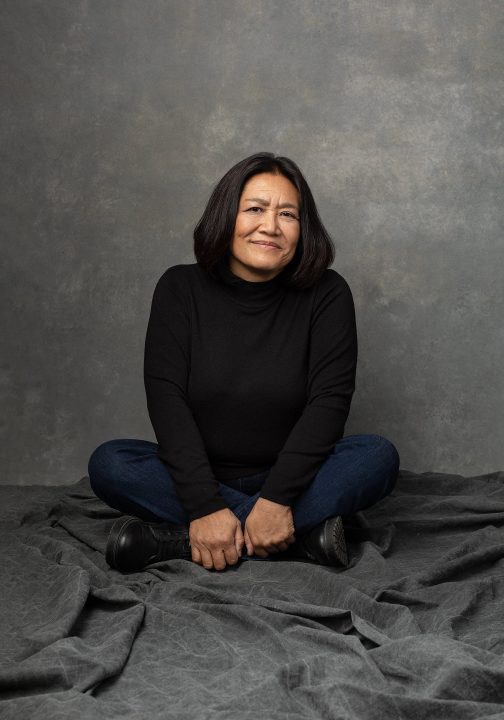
top-left (194, 152), bottom-right (334, 288)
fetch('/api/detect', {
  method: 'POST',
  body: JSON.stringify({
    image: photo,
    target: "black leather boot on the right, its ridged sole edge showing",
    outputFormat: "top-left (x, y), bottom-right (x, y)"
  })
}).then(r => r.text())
top-left (287, 516), bottom-right (348, 567)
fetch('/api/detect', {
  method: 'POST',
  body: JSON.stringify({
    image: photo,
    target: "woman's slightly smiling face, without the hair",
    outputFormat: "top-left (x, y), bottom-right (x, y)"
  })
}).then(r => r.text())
top-left (229, 173), bottom-right (300, 282)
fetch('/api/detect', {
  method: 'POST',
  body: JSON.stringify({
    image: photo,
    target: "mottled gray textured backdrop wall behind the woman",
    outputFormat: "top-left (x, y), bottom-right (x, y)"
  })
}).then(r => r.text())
top-left (0, 0), bottom-right (504, 484)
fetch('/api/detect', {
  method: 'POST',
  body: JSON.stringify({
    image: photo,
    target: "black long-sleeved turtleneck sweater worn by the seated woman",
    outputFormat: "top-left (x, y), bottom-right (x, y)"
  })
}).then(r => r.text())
top-left (144, 264), bottom-right (357, 520)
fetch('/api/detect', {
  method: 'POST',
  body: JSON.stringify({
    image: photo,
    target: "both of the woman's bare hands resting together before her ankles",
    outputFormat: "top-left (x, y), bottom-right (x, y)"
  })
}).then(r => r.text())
top-left (189, 498), bottom-right (295, 570)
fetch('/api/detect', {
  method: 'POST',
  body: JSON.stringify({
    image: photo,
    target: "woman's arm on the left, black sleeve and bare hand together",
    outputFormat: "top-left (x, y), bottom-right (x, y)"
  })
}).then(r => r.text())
top-left (144, 270), bottom-right (244, 570)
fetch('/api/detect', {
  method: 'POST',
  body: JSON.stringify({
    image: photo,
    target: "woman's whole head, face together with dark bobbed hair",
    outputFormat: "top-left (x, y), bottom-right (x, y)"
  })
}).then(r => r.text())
top-left (194, 153), bottom-right (334, 287)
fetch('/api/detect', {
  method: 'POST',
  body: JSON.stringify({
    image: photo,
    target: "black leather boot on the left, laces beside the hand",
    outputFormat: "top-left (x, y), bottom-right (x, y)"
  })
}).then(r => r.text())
top-left (105, 517), bottom-right (191, 572)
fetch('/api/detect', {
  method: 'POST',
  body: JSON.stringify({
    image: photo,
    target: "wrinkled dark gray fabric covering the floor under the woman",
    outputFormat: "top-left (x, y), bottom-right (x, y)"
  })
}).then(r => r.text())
top-left (0, 472), bottom-right (504, 720)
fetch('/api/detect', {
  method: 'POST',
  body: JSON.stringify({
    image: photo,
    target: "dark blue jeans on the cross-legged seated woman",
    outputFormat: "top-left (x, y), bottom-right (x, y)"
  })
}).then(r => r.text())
top-left (88, 435), bottom-right (399, 535)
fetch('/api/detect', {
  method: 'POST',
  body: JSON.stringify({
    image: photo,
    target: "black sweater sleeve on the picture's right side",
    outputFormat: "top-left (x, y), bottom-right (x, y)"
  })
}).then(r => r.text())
top-left (261, 272), bottom-right (357, 505)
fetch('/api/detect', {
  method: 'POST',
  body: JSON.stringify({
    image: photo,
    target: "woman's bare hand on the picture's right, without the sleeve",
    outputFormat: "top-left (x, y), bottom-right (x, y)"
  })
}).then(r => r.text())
top-left (245, 498), bottom-right (295, 557)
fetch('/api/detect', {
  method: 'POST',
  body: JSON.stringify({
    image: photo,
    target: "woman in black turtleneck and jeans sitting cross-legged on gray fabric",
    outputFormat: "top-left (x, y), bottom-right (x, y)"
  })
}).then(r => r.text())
top-left (89, 153), bottom-right (399, 572)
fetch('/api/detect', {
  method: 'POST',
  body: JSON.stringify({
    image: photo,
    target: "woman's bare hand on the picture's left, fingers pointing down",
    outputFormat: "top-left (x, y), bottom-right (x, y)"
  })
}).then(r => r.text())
top-left (189, 508), bottom-right (244, 570)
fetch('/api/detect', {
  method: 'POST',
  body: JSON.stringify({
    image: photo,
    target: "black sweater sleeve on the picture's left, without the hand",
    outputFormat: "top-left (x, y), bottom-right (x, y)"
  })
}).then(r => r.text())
top-left (144, 270), bottom-right (227, 520)
